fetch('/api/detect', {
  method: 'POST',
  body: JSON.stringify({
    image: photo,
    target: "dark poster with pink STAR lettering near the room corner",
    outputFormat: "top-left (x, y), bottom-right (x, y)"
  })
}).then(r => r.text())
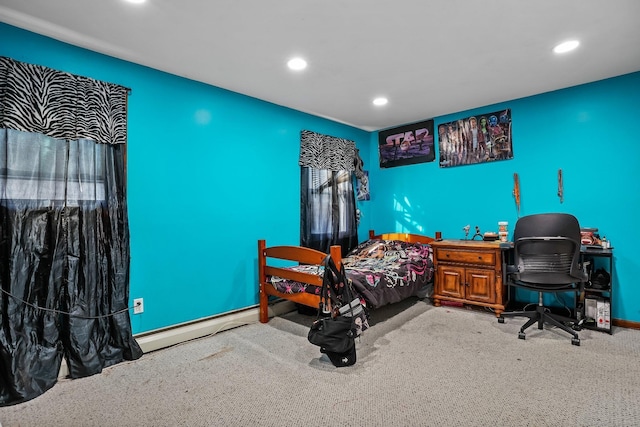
top-left (378, 119), bottom-right (436, 168)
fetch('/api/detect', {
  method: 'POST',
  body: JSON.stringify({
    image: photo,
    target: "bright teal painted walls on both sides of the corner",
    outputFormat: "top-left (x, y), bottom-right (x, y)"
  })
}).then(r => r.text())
top-left (0, 23), bottom-right (640, 333)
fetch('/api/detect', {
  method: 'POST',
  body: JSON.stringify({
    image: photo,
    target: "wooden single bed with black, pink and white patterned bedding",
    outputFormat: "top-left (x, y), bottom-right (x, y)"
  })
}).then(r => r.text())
top-left (258, 231), bottom-right (434, 323)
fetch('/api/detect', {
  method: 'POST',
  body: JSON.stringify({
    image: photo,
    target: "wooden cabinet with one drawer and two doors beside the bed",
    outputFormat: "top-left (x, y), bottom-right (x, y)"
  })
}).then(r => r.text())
top-left (430, 240), bottom-right (506, 317)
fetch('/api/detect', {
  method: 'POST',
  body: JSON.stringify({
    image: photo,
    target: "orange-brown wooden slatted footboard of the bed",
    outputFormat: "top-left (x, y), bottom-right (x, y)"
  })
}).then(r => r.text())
top-left (258, 240), bottom-right (342, 323)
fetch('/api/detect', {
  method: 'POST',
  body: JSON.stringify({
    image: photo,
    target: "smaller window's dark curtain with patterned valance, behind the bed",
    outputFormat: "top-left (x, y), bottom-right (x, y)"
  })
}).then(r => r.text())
top-left (299, 131), bottom-right (362, 255)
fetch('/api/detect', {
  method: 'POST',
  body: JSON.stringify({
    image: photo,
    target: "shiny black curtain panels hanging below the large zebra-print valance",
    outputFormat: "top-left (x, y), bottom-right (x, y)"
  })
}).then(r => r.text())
top-left (0, 129), bottom-right (142, 404)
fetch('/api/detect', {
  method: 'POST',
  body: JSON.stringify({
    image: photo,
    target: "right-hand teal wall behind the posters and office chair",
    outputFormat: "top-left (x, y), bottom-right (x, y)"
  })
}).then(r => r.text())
top-left (366, 73), bottom-right (640, 322)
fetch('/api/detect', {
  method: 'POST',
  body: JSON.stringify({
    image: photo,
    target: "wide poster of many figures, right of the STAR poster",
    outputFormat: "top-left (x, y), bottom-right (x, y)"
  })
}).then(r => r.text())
top-left (438, 109), bottom-right (513, 168)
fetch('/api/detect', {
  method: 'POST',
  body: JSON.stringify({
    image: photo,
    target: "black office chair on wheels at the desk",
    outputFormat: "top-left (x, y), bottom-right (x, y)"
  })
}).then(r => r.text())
top-left (498, 213), bottom-right (587, 345)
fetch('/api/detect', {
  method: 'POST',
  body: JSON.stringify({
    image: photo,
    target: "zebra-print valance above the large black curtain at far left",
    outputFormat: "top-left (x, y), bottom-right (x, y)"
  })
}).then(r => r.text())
top-left (0, 57), bottom-right (128, 144)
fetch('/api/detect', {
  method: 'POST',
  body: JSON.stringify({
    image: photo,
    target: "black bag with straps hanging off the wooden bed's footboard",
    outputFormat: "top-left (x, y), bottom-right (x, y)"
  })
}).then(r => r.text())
top-left (308, 256), bottom-right (356, 367)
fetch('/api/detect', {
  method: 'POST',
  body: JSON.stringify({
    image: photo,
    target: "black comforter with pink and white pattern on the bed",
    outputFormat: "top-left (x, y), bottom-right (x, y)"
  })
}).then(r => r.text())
top-left (264, 239), bottom-right (434, 308)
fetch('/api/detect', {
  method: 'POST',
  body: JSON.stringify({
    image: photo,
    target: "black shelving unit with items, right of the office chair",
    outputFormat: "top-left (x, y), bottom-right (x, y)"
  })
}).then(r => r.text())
top-left (580, 246), bottom-right (613, 334)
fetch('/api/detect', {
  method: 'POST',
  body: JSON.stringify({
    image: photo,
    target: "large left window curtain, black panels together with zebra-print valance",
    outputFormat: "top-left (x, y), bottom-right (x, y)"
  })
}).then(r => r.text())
top-left (0, 58), bottom-right (142, 405)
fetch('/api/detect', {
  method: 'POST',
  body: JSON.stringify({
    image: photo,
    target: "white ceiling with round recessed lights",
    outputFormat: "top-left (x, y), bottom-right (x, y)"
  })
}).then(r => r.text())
top-left (0, 0), bottom-right (640, 130)
